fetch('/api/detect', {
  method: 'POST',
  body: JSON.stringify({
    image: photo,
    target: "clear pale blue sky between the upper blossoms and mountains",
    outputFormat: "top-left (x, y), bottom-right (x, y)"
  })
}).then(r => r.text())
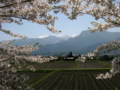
top-left (0, 14), bottom-right (120, 41)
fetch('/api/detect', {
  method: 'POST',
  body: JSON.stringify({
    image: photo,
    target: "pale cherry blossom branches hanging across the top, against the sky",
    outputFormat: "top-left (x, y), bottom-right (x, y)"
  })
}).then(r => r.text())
top-left (0, 0), bottom-right (120, 38)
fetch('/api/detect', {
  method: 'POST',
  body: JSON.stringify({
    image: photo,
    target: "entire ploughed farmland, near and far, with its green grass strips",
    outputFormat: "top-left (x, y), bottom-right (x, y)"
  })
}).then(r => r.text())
top-left (14, 61), bottom-right (120, 90)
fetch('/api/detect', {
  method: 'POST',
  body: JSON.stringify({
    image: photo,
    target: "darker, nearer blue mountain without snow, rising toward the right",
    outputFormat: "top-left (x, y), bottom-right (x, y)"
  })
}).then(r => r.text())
top-left (32, 31), bottom-right (120, 55)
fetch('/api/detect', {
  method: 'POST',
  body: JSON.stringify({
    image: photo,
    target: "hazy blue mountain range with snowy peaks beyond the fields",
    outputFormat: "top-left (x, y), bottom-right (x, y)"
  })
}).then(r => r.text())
top-left (1, 31), bottom-right (120, 55)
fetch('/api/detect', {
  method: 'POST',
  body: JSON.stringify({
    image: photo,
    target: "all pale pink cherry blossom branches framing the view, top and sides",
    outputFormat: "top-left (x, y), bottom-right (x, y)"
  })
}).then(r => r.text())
top-left (0, 0), bottom-right (120, 90)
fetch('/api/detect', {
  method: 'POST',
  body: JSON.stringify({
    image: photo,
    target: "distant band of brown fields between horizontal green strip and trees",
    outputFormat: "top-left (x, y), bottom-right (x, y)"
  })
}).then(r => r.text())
top-left (13, 61), bottom-right (111, 69)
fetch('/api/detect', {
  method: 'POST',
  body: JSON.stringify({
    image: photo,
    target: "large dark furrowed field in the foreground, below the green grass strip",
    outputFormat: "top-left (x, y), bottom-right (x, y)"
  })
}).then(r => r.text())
top-left (29, 71), bottom-right (120, 90)
